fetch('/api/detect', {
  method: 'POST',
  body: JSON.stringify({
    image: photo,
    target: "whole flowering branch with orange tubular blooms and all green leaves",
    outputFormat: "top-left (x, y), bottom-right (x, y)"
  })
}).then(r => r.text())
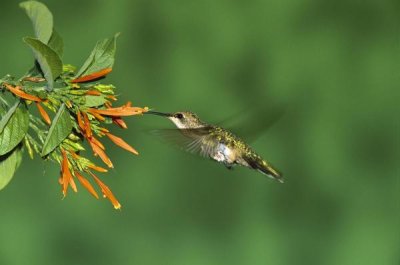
top-left (0, 1), bottom-right (148, 209)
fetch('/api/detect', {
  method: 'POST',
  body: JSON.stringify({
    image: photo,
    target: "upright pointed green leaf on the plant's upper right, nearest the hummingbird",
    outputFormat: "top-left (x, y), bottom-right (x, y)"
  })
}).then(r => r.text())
top-left (75, 33), bottom-right (119, 78)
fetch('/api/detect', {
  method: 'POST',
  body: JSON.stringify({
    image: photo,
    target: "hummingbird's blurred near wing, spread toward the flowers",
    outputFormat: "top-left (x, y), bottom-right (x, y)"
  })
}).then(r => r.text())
top-left (151, 127), bottom-right (217, 157)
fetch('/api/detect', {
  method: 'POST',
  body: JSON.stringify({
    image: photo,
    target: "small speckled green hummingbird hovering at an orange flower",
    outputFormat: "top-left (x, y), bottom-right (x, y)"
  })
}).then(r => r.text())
top-left (146, 110), bottom-right (283, 183)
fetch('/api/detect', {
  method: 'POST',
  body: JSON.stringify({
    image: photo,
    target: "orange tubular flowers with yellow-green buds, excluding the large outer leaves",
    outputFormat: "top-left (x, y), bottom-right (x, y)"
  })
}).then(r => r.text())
top-left (0, 65), bottom-right (148, 209)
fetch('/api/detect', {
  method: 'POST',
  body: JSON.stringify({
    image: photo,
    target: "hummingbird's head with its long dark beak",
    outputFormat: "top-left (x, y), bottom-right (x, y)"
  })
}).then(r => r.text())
top-left (147, 111), bottom-right (206, 129)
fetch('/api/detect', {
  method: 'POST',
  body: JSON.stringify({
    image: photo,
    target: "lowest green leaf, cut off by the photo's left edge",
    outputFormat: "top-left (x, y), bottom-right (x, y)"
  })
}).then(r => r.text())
top-left (0, 146), bottom-right (22, 190)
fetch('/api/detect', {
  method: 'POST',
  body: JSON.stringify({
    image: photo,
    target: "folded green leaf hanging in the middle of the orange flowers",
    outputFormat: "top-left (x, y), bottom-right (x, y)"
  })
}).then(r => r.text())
top-left (41, 104), bottom-right (72, 157)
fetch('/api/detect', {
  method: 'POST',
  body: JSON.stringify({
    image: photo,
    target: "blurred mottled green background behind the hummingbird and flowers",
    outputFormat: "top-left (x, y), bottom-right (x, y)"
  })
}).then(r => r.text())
top-left (0, 0), bottom-right (400, 265)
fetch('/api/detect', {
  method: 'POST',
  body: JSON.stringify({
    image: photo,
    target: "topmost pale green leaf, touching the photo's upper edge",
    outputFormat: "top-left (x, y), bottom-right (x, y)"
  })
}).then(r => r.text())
top-left (19, 1), bottom-right (53, 43)
